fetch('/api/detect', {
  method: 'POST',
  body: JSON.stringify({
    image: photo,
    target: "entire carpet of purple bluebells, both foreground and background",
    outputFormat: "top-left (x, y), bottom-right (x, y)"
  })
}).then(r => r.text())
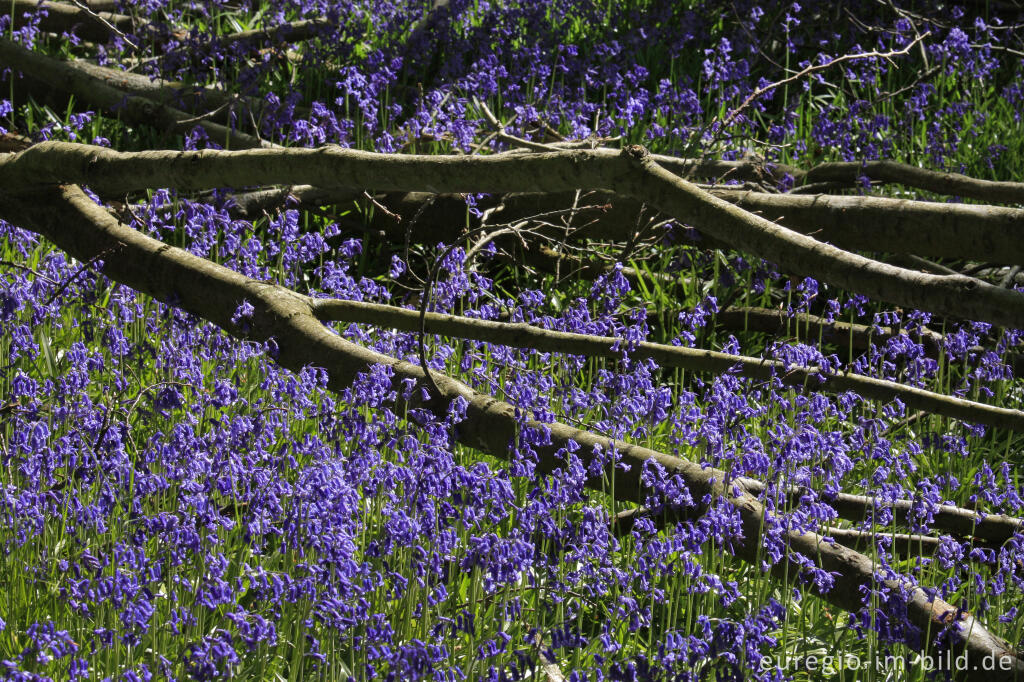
top-left (0, 0), bottom-right (1024, 681)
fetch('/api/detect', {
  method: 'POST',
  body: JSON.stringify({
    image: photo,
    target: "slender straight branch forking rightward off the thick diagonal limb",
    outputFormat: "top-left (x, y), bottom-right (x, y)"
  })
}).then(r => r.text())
top-left (312, 299), bottom-right (1024, 431)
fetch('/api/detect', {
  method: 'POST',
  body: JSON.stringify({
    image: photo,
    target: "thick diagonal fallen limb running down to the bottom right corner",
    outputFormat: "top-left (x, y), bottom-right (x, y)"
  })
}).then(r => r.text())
top-left (0, 185), bottom-right (1024, 682)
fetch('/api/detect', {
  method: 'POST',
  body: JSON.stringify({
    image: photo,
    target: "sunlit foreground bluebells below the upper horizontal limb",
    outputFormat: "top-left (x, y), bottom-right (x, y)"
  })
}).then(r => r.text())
top-left (0, 183), bottom-right (1024, 679)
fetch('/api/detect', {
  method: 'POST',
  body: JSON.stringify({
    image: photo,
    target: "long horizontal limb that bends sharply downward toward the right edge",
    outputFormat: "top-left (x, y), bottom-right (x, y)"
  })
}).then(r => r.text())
top-left (6, 142), bottom-right (1024, 328)
